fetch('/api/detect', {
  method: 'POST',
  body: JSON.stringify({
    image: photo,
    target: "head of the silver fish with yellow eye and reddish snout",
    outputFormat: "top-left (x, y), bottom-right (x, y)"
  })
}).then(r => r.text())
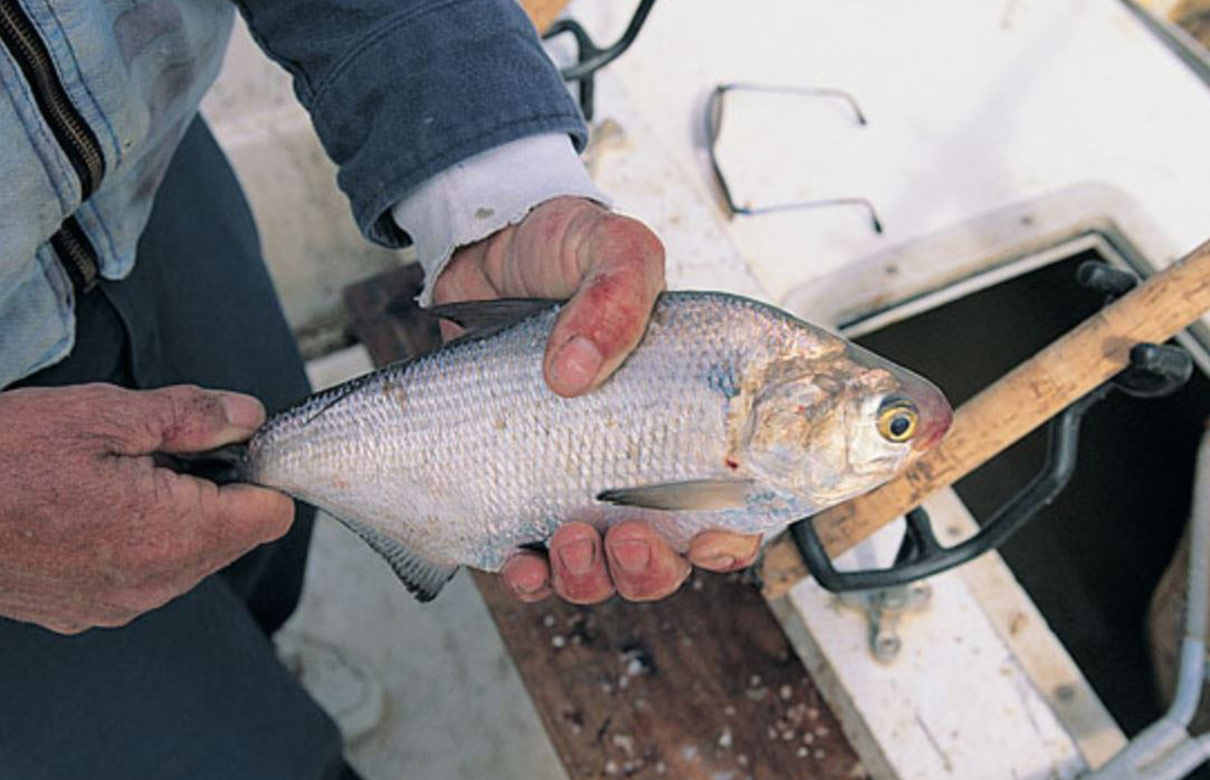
top-left (743, 343), bottom-right (953, 509)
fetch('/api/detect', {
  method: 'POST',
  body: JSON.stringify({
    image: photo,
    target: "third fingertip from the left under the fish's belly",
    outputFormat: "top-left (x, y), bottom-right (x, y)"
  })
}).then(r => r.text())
top-left (605, 520), bottom-right (692, 601)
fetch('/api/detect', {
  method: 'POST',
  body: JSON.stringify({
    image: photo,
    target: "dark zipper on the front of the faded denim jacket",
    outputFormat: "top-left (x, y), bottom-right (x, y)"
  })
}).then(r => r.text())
top-left (0, 0), bottom-right (105, 293)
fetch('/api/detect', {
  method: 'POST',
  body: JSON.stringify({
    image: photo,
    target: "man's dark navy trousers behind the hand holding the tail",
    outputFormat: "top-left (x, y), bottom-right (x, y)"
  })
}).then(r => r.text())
top-left (0, 120), bottom-right (353, 780)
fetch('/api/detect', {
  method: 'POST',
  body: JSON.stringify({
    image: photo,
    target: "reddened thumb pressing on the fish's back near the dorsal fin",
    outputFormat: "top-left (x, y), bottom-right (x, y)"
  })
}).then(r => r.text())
top-left (545, 214), bottom-right (664, 395)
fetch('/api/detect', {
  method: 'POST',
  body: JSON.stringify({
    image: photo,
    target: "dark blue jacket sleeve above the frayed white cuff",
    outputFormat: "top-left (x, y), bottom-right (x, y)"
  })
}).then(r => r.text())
top-left (236, 0), bottom-right (587, 247)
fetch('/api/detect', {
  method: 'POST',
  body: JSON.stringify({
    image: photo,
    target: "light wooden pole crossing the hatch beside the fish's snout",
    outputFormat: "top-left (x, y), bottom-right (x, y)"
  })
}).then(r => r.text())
top-left (764, 242), bottom-right (1210, 599)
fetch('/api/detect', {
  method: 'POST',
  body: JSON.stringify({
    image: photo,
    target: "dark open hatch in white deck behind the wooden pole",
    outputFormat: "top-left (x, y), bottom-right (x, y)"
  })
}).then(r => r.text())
top-left (857, 250), bottom-right (1210, 734)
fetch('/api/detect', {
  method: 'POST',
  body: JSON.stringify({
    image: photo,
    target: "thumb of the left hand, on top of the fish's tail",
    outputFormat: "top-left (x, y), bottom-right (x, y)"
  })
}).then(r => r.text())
top-left (109, 385), bottom-right (265, 455)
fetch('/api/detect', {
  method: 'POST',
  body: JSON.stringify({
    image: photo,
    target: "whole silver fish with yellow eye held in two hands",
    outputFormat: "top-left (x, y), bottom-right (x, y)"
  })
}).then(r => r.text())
top-left (242, 291), bottom-right (951, 600)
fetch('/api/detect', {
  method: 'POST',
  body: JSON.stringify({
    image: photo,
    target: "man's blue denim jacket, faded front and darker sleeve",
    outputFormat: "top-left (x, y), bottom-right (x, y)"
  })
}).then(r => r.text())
top-left (0, 0), bottom-right (584, 388)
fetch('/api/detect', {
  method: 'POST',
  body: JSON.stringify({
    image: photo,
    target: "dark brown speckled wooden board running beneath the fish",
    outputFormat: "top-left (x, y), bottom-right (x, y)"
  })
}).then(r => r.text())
top-left (345, 266), bottom-right (865, 780)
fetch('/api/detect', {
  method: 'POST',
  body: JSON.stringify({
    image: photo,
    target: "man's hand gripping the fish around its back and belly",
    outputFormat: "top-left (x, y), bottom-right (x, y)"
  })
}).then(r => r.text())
top-left (433, 198), bottom-right (760, 603)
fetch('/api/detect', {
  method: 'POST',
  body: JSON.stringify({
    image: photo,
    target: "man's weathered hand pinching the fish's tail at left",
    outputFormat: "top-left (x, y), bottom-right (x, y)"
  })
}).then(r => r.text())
top-left (0, 385), bottom-right (294, 634)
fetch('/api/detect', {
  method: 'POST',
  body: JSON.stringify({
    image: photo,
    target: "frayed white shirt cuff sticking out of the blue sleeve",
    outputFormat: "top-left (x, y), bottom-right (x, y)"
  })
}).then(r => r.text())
top-left (391, 133), bottom-right (610, 306)
